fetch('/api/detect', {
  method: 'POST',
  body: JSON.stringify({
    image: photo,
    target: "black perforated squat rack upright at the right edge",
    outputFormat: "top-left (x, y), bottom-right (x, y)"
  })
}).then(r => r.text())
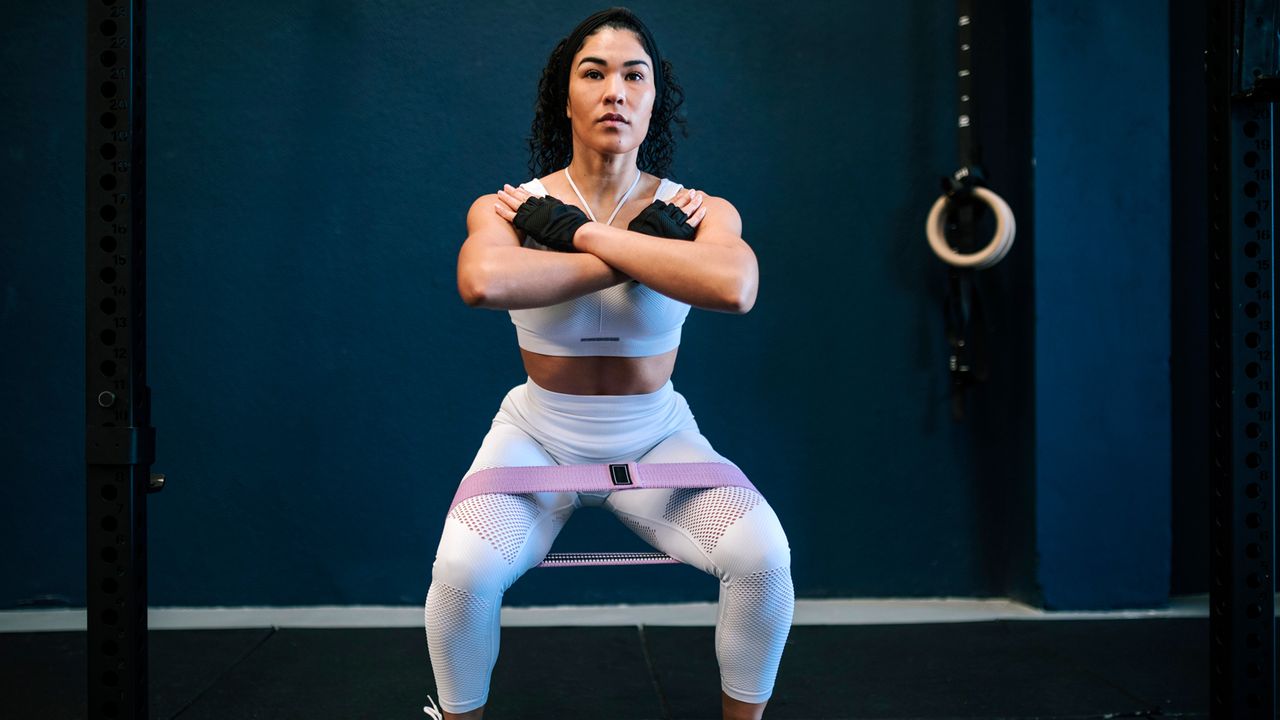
top-left (1204, 0), bottom-right (1280, 720)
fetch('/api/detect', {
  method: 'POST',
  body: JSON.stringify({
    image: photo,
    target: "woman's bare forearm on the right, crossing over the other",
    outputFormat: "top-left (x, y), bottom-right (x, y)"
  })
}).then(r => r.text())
top-left (573, 223), bottom-right (756, 313)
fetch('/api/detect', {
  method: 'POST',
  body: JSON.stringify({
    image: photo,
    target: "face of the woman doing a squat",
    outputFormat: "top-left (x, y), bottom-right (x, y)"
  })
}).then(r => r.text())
top-left (564, 27), bottom-right (657, 152)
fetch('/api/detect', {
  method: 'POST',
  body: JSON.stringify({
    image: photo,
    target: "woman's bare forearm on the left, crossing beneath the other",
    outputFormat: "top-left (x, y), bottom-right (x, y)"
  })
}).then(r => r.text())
top-left (458, 247), bottom-right (628, 310)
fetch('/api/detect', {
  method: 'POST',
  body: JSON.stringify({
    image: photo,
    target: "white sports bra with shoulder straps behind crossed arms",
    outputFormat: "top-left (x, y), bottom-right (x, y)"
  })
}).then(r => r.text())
top-left (508, 178), bottom-right (689, 357)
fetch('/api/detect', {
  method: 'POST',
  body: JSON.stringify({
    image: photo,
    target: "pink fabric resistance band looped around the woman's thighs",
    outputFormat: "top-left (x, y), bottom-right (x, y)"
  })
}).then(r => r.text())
top-left (449, 462), bottom-right (759, 568)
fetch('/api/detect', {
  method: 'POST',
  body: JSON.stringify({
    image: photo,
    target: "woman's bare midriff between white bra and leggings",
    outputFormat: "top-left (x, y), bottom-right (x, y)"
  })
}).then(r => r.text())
top-left (520, 347), bottom-right (680, 395)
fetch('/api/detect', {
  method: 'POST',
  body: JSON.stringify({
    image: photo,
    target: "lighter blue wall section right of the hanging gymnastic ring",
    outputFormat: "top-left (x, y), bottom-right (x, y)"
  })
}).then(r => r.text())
top-left (1032, 0), bottom-right (1171, 607)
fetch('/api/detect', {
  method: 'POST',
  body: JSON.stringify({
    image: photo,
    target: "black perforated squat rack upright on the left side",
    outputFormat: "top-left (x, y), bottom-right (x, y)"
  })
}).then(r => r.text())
top-left (84, 0), bottom-right (164, 720)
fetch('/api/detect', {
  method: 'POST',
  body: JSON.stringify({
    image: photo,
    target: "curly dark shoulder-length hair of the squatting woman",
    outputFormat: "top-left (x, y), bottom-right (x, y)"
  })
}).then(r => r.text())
top-left (529, 8), bottom-right (689, 177)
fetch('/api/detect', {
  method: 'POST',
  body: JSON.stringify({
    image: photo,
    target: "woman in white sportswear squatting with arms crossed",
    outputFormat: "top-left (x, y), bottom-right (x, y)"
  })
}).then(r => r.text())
top-left (424, 8), bottom-right (795, 720)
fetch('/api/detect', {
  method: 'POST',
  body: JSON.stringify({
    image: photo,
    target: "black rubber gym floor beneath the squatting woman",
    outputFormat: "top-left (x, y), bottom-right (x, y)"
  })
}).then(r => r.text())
top-left (10, 618), bottom-right (1208, 720)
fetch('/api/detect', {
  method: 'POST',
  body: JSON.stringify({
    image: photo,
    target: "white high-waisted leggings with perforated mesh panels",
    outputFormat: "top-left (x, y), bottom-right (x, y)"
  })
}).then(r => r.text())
top-left (425, 379), bottom-right (795, 712)
